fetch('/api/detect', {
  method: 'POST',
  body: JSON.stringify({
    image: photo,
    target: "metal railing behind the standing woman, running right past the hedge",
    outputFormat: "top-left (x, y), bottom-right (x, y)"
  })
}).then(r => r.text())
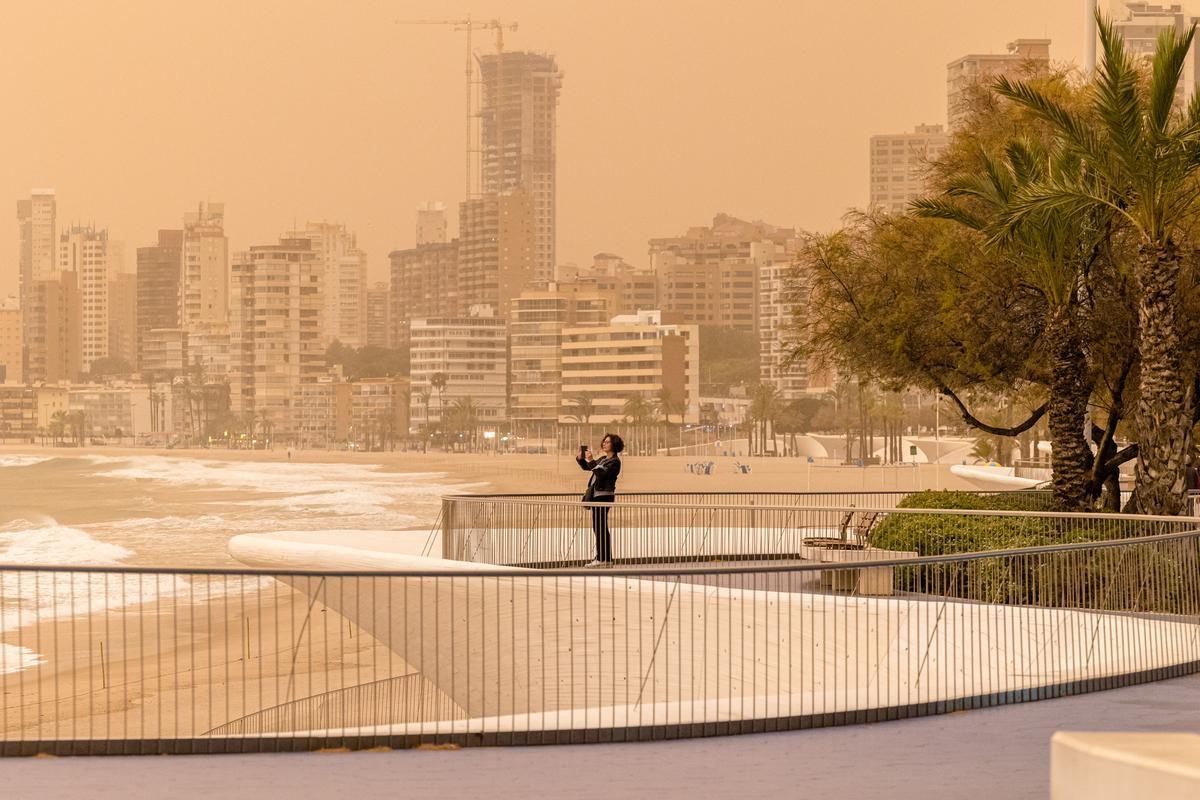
top-left (440, 495), bottom-right (1200, 569)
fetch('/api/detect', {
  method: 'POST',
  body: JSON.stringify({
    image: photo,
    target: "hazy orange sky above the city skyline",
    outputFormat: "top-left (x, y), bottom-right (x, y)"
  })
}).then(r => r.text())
top-left (0, 0), bottom-right (1084, 295)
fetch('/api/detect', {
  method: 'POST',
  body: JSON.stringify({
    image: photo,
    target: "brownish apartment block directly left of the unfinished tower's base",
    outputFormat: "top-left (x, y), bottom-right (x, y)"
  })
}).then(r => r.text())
top-left (388, 239), bottom-right (467, 348)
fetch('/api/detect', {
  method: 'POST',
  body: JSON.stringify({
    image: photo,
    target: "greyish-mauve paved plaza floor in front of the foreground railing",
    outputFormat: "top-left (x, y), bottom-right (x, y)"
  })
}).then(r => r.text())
top-left (0, 675), bottom-right (1200, 800)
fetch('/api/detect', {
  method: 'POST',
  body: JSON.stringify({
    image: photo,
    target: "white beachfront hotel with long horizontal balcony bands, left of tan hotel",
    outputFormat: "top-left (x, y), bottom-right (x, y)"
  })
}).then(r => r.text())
top-left (409, 307), bottom-right (509, 429)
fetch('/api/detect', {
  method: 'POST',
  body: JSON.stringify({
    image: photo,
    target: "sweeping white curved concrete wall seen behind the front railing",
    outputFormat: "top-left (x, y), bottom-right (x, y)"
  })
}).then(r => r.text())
top-left (223, 534), bottom-right (1200, 732)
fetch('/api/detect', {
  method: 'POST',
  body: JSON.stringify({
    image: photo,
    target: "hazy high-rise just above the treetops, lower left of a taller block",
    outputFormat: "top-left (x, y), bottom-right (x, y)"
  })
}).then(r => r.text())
top-left (870, 125), bottom-right (949, 213)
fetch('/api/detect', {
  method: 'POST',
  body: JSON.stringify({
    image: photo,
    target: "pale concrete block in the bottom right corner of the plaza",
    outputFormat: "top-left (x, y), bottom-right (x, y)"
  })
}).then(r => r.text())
top-left (1050, 732), bottom-right (1200, 800)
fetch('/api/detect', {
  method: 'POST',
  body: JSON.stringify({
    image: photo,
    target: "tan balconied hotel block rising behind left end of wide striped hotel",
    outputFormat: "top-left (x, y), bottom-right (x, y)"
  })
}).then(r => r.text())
top-left (509, 282), bottom-right (617, 425)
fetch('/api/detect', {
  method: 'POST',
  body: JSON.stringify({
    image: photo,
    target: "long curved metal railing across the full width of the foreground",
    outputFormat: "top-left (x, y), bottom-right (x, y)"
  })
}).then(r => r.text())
top-left (0, 527), bottom-right (1200, 754)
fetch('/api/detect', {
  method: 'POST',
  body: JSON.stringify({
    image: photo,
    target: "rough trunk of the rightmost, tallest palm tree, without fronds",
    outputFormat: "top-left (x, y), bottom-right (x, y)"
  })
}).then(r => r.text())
top-left (1135, 241), bottom-right (1192, 515)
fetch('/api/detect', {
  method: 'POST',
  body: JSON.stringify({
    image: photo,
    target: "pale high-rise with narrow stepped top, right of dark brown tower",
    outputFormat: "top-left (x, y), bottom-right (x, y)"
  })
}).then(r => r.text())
top-left (179, 203), bottom-right (229, 332)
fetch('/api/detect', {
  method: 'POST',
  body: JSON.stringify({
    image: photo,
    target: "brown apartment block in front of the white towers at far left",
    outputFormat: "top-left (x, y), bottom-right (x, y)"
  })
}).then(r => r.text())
top-left (23, 272), bottom-right (84, 384)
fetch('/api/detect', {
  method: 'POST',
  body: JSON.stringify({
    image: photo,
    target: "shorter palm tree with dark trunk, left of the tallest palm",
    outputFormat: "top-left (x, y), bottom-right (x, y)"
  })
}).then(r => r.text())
top-left (913, 139), bottom-right (1111, 510)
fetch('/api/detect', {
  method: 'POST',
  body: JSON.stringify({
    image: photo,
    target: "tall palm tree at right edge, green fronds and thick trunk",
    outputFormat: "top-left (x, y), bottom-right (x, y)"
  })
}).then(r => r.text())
top-left (996, 13), bottom-right (1200, 513)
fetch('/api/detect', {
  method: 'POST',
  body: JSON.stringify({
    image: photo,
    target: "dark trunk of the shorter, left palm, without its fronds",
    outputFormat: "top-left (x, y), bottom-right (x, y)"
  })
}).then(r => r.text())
top-left (1046, 309), bottom-right (1094, 511)
